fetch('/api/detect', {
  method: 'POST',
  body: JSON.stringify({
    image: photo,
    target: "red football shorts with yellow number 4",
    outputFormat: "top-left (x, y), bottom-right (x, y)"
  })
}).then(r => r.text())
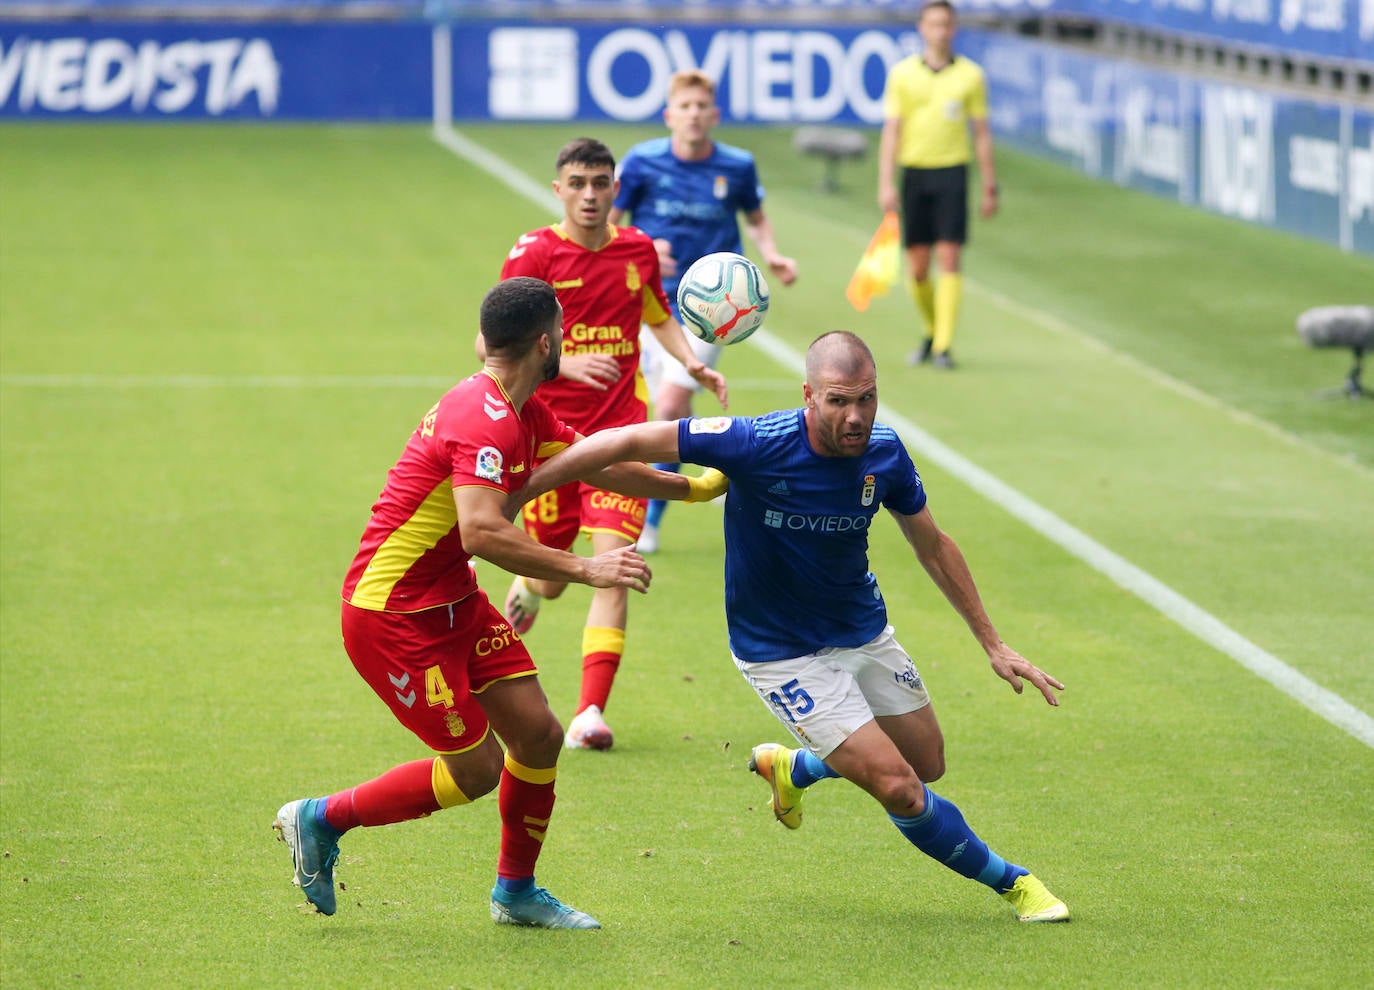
top-left (344, 590), bottom-right (537, 752)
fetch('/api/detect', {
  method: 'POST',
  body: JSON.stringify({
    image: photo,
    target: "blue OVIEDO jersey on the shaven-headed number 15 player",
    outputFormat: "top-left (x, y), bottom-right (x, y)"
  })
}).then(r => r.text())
top-left (677, 409), bottom-right (926, 663)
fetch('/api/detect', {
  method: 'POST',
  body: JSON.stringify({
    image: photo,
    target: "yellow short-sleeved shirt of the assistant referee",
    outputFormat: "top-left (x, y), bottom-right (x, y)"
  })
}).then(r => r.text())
top-left (882, 55), bottom-right (988, 169)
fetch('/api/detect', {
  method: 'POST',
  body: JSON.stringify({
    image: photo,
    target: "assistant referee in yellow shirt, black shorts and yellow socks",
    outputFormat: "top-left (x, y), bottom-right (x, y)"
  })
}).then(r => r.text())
top-left (878, 0), bottom-right (998, 368)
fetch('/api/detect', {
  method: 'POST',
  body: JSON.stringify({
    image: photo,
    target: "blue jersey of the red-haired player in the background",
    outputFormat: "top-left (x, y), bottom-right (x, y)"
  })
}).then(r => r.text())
top-left (616, 137), bottom-right (764, 308)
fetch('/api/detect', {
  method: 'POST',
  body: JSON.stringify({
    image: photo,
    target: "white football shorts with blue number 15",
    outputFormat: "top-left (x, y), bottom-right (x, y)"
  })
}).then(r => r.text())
top-left (731, 626), bottom-right (930, 759)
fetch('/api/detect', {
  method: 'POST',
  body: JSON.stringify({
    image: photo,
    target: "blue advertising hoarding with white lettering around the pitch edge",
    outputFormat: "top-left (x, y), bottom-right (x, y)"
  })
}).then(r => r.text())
top-left (0, 21), bottom-right (1374, 254)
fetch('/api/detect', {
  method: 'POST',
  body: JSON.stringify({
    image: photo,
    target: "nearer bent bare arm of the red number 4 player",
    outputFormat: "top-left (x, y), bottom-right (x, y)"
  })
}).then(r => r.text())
top-left (453, 485), bottom-right (651, 592)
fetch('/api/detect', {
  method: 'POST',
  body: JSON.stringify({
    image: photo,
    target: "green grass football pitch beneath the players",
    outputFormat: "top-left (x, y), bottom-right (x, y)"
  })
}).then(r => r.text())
top-left (0, 125), bottom-right (1374, 989)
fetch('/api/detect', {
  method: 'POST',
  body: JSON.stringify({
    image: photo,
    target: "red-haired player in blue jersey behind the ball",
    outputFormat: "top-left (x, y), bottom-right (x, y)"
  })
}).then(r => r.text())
top-left (610, 70), bottom-right (797, 553)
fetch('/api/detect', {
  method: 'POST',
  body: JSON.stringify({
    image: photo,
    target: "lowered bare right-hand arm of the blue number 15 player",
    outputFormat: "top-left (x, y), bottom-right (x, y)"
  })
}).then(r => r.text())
top-left (892, 508), bottom-right (1063, 706)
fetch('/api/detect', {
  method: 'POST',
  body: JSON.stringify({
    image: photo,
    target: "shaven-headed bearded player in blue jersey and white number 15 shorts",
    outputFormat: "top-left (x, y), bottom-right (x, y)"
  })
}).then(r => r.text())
top-left (522, 331), bottom-right (1069, 921)
